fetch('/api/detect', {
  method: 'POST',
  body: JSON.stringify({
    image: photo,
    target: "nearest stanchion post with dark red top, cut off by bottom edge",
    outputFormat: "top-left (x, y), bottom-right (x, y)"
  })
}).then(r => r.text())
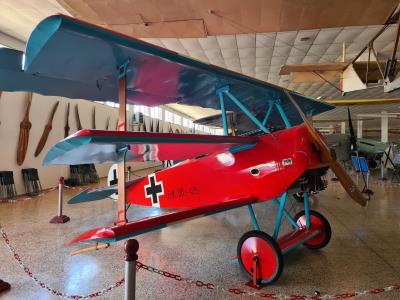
top-left (124, 239), bottom-right (139, 300)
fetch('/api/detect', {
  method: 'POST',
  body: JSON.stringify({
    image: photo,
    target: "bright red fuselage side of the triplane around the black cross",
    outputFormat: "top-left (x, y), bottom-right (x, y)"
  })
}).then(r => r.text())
top-left (127, 125), bottom-right (320, 209)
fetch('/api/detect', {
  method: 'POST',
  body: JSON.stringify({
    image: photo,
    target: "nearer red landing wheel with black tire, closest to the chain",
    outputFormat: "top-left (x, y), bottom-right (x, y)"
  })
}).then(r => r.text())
top-left (237, 230), bottom-right (283, 285)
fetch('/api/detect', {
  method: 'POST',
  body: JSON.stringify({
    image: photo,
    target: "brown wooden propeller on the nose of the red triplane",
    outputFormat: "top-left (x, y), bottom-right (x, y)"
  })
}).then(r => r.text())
top-left (284, 90), bottom-right (368, 206)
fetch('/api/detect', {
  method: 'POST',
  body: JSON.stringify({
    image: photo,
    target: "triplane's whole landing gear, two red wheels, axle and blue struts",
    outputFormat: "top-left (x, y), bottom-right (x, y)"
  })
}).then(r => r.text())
top-left (237, 192), bottom-right (332, 287)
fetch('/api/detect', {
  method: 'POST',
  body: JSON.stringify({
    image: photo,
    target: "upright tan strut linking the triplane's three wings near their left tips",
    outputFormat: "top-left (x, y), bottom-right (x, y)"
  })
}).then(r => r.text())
top-left (114, 61), bottom-right (129, 225)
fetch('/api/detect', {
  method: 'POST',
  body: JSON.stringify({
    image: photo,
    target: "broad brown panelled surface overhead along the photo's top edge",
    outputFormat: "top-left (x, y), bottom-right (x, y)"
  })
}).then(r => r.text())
top-left (59, 0), bottom-right (398, 37)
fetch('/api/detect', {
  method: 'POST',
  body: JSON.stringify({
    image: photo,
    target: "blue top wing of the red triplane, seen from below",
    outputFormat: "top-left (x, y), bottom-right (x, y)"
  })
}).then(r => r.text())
top-left (0, 15), bottom-right (333, 124)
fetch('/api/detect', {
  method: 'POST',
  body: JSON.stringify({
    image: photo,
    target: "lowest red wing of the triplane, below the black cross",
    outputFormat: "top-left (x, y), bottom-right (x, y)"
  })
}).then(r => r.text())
top-left (69, 198), bottom-right (256, 244)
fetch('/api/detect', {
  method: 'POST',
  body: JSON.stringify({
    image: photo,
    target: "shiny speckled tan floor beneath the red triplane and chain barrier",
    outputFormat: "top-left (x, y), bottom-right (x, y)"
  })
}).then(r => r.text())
top-left (0, 168), bottom-right (400, 300)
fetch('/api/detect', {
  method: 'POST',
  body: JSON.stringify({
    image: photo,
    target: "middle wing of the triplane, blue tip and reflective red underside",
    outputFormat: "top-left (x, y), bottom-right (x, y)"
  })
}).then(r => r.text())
top-left (43, 129), bottom-right (258, 165)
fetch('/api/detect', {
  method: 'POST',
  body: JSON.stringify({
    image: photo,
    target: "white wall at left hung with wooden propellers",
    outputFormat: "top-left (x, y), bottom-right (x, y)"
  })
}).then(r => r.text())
top-left (0, 92), bottom-right (159, 194)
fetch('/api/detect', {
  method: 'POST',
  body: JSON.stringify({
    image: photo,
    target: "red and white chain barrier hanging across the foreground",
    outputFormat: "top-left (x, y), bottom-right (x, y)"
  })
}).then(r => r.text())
top-left (0, 224), bottom-right (400, 300)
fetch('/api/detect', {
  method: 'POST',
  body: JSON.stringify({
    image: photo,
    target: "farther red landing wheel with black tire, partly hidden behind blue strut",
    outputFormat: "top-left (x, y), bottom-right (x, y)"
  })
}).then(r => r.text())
top-left (294, 210), bottom-right (332, 249)
